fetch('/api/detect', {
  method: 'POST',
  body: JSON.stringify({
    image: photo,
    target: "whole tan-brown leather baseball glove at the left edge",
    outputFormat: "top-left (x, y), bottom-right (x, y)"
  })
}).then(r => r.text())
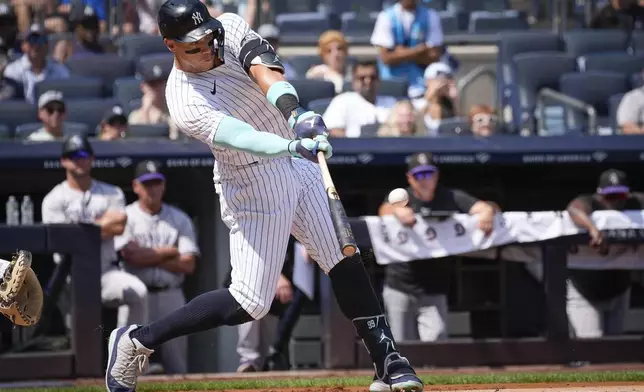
top-left (0, 250), bottom-right (43, 326)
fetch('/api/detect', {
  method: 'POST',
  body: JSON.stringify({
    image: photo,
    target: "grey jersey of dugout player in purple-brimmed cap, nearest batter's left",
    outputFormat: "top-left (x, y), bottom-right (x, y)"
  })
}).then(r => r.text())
top-left (114, 202), bottom-right (199, 287)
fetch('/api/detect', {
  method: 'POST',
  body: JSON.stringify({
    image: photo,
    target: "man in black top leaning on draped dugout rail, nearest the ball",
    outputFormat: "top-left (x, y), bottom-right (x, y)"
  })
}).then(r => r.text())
top-left (378, 153), bottom-right (498, 342)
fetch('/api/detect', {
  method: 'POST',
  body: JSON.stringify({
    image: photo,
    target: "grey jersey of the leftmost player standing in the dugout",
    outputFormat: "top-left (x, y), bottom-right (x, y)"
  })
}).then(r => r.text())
top-left (41, 180), bottom-right (125, 272)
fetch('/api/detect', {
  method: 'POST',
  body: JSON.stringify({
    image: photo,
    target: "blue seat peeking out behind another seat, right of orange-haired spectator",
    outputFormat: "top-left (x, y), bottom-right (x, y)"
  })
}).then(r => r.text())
top-left (496, 31), bottom-right (563, 133)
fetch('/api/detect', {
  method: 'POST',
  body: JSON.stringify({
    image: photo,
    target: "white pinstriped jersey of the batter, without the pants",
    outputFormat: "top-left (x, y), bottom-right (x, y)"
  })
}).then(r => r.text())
top-left (166, 13), bottom-right (294, 165)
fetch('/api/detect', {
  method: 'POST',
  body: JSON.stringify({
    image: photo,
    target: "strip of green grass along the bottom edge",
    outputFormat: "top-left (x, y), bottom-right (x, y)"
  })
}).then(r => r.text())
top-left (3, 371), bottom-right (644, 392)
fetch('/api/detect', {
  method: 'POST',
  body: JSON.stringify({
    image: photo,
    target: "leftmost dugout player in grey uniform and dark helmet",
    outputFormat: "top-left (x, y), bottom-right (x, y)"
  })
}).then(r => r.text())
top-left (42, 135), bottom-right (148, 327)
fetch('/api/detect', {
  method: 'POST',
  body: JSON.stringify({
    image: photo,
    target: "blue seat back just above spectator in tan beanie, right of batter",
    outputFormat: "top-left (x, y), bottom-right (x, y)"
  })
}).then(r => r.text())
top-left (275, 12), bottom-right (342, 44)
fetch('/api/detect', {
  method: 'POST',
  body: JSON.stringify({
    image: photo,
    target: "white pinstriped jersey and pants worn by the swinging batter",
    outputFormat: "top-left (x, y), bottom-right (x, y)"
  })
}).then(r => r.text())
top-left (166, 13), bottom-right (343, 319)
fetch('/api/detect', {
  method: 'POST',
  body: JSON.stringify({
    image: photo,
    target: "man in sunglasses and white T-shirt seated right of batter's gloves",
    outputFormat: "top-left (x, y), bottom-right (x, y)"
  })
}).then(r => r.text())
top-left (323, 60), bottom-right (396, 137)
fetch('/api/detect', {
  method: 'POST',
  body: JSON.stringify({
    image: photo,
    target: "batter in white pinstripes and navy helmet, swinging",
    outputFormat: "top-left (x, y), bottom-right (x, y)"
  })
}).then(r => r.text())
top-left (105, 0), bottom-right (423, 392)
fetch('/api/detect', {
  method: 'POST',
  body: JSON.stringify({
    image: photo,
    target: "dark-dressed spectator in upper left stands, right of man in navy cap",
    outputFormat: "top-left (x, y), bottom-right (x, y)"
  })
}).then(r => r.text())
top-left (53, 4), bottom-right (114, 63)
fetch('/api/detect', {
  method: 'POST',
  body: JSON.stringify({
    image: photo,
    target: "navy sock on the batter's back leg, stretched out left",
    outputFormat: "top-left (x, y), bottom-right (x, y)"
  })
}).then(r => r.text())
top-left (130, 289), bottom-right (252, 349)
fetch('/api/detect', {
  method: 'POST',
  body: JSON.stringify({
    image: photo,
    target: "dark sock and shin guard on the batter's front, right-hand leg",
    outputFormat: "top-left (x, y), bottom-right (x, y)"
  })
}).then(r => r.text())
top-left (329, 254), bottom-right (397, 368)
